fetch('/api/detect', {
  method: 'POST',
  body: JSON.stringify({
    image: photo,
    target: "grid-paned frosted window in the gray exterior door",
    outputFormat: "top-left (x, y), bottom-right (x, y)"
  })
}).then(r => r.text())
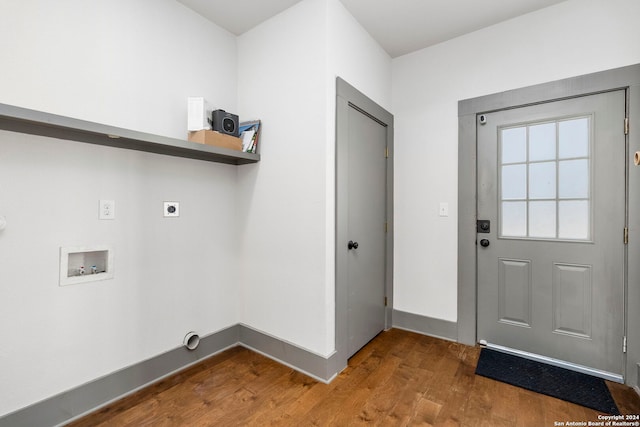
top-left (498, 116), bottom-right (592, 241)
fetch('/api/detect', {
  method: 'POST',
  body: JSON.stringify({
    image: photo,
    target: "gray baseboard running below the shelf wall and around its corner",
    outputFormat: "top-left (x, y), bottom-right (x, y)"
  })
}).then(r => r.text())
top-left (0, 324), bottom-right (337, 427)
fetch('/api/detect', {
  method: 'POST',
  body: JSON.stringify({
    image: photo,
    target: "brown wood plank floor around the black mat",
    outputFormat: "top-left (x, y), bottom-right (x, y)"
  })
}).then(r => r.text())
top-left (69, 329), bottom-right (640, 427)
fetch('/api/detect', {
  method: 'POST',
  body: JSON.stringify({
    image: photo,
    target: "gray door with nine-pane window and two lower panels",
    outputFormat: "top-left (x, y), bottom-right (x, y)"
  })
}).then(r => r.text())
top-left (477, 91), bottom-right (626, 379)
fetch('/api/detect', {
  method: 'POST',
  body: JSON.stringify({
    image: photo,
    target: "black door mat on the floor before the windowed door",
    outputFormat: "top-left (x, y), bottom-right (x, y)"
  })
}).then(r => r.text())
top-left (476, 348), bottom-right (620, 415)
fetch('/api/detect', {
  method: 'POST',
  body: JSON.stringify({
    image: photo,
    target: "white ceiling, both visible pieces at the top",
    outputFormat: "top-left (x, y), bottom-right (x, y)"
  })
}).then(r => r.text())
top-left (178, 0), bottom-right (565, 58)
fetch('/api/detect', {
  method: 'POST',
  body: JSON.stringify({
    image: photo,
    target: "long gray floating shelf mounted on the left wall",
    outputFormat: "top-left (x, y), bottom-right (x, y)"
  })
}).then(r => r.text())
top-left (0, 104), bottom-right (260, 165)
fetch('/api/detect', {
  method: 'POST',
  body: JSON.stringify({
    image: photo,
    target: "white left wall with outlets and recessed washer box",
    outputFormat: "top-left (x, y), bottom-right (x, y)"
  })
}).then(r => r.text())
top-left (0, 0), bottom-right (239, 416)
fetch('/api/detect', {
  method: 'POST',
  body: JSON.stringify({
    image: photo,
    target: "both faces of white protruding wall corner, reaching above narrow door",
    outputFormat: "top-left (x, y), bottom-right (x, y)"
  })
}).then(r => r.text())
top-left (238, 0), bottom-right (391, 356)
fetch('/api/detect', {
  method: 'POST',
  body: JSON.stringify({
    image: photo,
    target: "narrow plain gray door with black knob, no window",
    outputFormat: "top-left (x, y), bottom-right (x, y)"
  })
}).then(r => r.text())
top-left (339, 106), bottom-right (387, 357)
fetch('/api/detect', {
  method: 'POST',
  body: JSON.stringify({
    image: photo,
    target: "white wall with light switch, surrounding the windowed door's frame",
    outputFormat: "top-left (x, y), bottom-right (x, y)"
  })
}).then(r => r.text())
top-left (392, 0), bottom-right (640, 322)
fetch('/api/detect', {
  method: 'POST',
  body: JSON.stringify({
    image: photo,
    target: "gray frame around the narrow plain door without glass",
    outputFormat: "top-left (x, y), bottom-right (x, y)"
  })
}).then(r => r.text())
top-left (333, 77), bottom-right (393, 372)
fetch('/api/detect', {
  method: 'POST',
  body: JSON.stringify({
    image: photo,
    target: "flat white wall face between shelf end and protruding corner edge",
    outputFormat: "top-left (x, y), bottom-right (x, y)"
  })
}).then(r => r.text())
top-left (238, 0), bottom-right (330, 354)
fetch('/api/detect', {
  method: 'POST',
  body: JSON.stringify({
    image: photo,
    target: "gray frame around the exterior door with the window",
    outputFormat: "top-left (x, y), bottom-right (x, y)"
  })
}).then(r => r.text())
top-left (457, 64), bottom-right (640, 387)
